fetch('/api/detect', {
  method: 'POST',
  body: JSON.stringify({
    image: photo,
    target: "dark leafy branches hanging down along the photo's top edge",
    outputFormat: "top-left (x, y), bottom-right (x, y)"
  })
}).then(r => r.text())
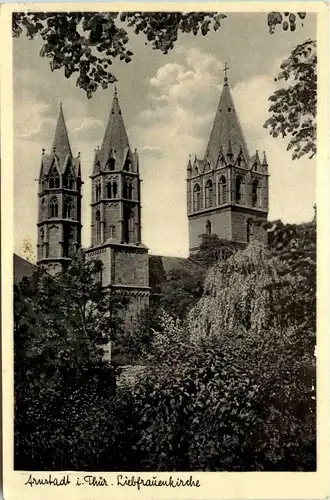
top-left (13, 12), bottom-right (304, 98)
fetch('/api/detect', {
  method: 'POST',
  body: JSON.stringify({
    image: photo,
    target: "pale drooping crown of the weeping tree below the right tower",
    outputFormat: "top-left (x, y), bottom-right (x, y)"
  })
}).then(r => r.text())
top-left (189, 241), bottom-right (293, 337)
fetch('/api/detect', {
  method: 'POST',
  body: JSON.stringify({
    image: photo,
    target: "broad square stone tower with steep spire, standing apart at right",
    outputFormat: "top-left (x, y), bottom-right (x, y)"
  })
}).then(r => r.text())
top-left (187, 68), bottom-right (269, 253)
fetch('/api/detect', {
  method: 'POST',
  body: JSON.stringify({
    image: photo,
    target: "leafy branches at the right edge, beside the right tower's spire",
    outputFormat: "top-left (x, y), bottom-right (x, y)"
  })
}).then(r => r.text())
top-left (264, 39), bottom-right (317, 159)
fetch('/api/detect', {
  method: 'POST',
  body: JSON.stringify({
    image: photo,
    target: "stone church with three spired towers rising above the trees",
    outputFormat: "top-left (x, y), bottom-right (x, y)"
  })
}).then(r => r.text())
top-left (14, 72), bottom-right (269, 326)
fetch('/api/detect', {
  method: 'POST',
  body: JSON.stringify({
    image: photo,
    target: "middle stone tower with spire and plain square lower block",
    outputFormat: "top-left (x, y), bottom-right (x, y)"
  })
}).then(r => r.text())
top-left (86, 91), bottom-right (150, 325)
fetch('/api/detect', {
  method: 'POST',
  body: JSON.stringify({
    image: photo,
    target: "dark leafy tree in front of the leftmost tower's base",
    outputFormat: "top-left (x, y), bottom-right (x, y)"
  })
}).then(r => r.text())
top-left (14, 252), bottom-right (123, 374)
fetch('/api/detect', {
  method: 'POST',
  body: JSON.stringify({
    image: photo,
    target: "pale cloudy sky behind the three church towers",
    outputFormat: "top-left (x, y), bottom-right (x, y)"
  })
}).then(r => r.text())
top-left (13, 13), bottom-right (316, 257)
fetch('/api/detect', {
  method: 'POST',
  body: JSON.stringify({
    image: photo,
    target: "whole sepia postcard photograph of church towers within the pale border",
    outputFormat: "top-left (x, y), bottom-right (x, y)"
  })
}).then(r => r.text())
top-left (2, 2), bottom-right (327, 498)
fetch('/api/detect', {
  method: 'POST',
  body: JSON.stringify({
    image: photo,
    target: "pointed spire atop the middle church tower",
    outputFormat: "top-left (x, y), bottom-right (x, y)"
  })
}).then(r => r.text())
top-left (99, 87), bottom-right (130, 170)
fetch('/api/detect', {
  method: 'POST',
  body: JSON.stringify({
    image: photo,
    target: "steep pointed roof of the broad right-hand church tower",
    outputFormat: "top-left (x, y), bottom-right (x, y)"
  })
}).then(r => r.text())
top-left (204, 78), bottom-right (250, 165)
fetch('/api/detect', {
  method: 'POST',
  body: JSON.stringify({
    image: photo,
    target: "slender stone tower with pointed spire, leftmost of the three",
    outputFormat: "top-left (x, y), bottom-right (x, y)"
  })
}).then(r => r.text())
top-left (37, 105), bottom-right (83, 274)
